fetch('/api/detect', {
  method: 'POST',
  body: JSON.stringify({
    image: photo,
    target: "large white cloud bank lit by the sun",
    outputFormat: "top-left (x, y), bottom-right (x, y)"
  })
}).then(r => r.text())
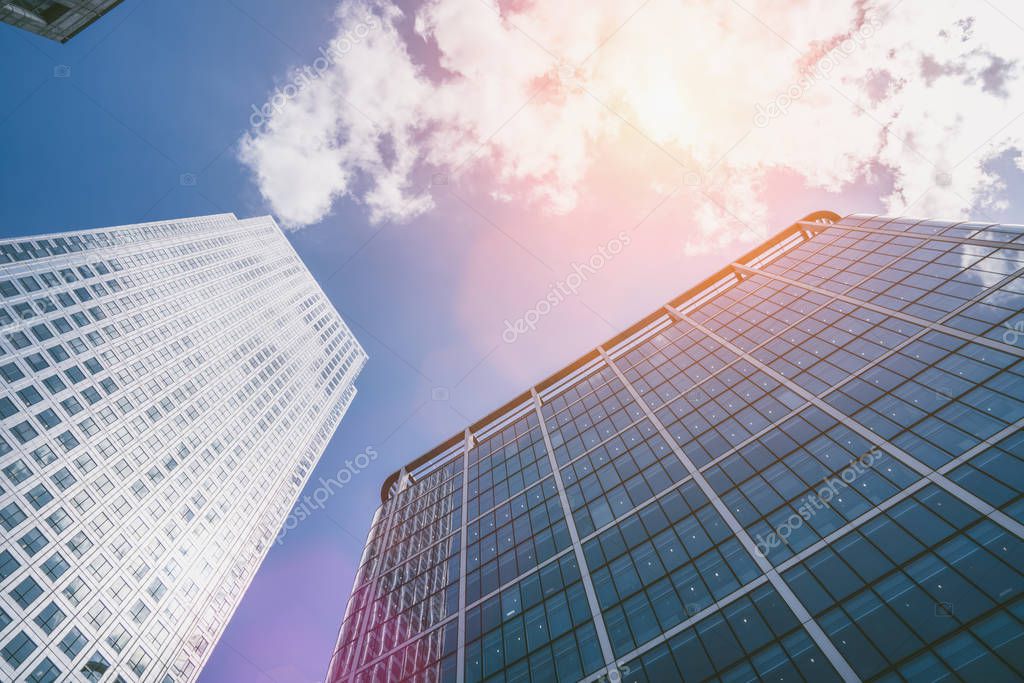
top-left (241, 0), bottom-right (1024, 251)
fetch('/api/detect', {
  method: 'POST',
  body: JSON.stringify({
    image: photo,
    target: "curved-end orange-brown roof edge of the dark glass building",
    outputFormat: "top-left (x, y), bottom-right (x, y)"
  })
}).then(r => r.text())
top-left (381, 211), bottom-right (842, 504)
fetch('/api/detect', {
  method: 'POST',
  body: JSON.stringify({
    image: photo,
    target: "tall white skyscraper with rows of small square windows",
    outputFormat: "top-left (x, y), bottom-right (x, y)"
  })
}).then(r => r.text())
top-left (0, 214), bottom-right (366, 683)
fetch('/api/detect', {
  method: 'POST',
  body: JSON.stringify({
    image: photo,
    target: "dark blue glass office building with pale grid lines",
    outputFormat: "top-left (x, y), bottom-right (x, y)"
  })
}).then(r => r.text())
top-left (327, 212), bottom-right (1024, 683)
